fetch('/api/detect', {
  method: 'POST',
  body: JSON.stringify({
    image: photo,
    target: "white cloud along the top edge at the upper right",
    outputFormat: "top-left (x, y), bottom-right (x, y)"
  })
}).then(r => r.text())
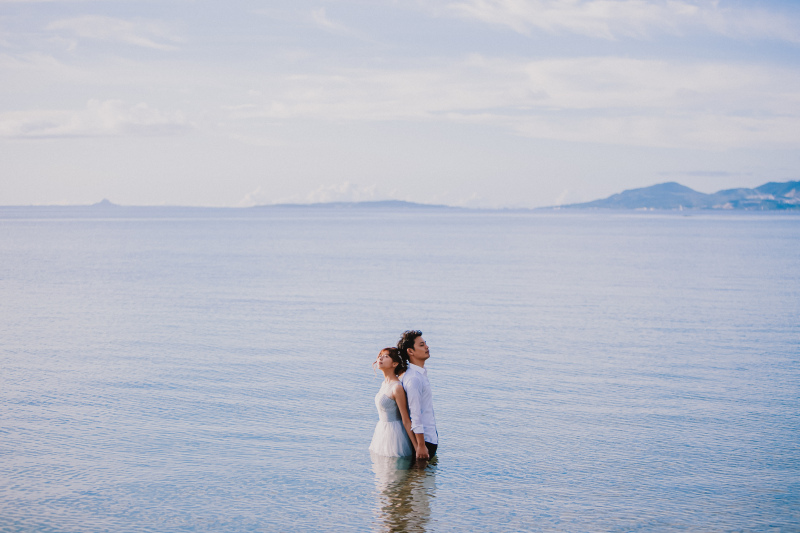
top-left (438, 0), bottom-right (800, 42)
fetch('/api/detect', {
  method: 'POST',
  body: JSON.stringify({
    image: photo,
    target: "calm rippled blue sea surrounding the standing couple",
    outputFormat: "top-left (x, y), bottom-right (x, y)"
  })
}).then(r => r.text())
top-left (0, 208), bottom-right (800, 532)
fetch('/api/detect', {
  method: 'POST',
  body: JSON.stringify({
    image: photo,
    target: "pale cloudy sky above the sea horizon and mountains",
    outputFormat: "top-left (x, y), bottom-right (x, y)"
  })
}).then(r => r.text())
top-left (0, 0), bottom-right (800, 208)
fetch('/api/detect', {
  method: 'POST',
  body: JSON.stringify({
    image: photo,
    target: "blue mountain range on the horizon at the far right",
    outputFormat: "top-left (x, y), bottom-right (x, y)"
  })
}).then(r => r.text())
top-left (561, 181), bottom-right (800, 211)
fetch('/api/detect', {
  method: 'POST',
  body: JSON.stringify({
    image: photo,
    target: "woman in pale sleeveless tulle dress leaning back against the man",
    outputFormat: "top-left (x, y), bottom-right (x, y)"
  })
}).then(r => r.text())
top-left (369, 348), bottom-right (415, 457)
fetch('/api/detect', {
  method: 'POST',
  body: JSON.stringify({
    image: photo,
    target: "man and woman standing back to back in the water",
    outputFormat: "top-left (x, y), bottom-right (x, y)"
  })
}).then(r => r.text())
top-left (369, 330), bottom-right (439, 461)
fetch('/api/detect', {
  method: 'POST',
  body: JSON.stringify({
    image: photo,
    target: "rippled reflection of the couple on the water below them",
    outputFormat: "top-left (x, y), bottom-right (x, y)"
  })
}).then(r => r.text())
top-left (372, 454), bottom-right (438, 533)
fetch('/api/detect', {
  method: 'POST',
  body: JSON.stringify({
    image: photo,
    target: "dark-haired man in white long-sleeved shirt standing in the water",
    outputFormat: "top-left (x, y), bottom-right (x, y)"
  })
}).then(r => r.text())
top-left (397, 330), bottom-right (439, 460)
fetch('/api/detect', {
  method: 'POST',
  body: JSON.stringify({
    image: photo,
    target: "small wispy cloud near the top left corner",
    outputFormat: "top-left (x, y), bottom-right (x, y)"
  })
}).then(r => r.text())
top-left (47, 15), bottom-right (181, 50)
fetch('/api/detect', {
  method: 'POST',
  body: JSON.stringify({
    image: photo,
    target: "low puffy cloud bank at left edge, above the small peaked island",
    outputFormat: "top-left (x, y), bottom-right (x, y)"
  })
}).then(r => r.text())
top-left (0, 100), bottom-right (191, 139)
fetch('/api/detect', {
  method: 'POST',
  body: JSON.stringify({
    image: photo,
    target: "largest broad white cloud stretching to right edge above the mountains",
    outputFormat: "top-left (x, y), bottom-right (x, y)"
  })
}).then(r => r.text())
top-left (228, 56), bottom-right (800, 148)
